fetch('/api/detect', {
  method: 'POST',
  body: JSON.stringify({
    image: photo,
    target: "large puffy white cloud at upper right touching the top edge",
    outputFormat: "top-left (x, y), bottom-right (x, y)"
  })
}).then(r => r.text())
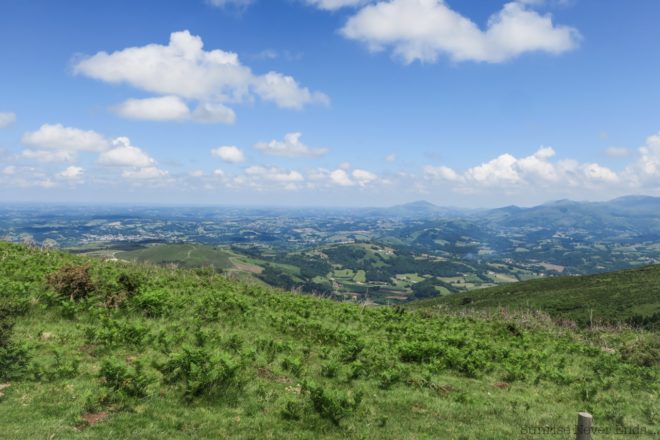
top-left (341, 0), bottom-right (581, 63)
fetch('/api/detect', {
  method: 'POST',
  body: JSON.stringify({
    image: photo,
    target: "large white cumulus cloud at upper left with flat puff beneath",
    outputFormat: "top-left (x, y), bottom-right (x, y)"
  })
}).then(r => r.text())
top-left (73, 31), bottom-right (328, 123)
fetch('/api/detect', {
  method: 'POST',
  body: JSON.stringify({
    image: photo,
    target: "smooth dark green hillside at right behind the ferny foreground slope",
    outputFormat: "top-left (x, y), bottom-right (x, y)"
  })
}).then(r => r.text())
top-left (411, 265), bottom-right (660, 327)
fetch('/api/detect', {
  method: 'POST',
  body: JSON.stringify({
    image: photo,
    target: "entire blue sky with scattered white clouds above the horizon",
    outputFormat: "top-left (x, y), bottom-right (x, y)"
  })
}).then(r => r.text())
top-left (0, 0), bottom-right (660, 207)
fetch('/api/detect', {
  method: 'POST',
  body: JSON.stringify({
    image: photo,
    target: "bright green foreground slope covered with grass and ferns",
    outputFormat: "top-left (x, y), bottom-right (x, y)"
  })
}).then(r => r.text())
top-left (0, 243), bottom-right (660, 439)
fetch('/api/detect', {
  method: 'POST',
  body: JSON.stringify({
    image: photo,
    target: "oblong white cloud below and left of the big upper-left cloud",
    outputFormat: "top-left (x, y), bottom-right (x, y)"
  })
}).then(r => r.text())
top-left (21, 124), bottom-right (108, 152)
